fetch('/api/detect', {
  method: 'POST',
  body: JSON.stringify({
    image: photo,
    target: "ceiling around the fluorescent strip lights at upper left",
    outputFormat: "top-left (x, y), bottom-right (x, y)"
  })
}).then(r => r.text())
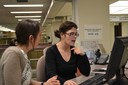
top-left (0, 0), bottom-right (128, 30)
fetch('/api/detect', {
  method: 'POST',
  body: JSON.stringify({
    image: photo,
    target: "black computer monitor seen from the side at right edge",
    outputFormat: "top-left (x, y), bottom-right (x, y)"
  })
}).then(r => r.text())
top-left (105, 36), bottom-right (128, 81)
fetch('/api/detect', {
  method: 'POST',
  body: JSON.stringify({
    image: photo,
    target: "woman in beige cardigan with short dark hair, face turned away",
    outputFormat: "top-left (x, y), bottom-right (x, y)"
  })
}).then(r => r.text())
top-left (0, 20), bottom-right (60, 85)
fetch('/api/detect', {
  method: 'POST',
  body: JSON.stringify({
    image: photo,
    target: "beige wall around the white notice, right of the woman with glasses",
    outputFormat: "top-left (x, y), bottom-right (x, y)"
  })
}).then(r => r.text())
top-left (73, 0), bottom-right (112, 53)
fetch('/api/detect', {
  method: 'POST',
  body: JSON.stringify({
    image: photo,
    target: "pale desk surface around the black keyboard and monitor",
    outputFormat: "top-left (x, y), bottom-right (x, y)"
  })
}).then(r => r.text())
top-left (72, 65), bottom-right (128, 85)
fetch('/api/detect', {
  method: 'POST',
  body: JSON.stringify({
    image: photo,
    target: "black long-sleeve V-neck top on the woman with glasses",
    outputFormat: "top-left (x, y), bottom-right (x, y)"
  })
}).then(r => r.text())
top-left (45, 45), bottom-right (90, 85)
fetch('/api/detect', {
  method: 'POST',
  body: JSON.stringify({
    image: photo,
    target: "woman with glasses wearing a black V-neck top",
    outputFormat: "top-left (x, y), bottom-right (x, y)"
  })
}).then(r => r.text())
top-left (45, 21), bottom-right (90, 85)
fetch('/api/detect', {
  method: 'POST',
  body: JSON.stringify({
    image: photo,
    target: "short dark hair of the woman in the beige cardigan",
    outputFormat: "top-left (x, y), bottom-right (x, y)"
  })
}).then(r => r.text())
top-left (15, 19), bottom-right (40, 45)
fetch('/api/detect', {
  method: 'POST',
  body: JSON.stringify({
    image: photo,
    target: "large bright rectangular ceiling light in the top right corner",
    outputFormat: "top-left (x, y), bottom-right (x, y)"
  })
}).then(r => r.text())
top-left (109, 1), bottom-right (128, 14)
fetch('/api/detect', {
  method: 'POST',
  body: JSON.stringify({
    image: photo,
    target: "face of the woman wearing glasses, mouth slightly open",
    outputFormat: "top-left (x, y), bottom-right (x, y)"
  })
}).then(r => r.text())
top-left (61, 27), bottom-right (79, 46)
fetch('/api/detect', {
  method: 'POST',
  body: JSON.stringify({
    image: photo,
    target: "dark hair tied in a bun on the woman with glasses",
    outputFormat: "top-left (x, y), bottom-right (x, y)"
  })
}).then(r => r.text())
top-left (54, 21), bottom-right (78, 38)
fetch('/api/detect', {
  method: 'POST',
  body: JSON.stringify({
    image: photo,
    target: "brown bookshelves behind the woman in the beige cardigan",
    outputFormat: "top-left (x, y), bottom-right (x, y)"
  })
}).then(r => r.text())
top-left (0, 31), bottom-right (51, 78)
